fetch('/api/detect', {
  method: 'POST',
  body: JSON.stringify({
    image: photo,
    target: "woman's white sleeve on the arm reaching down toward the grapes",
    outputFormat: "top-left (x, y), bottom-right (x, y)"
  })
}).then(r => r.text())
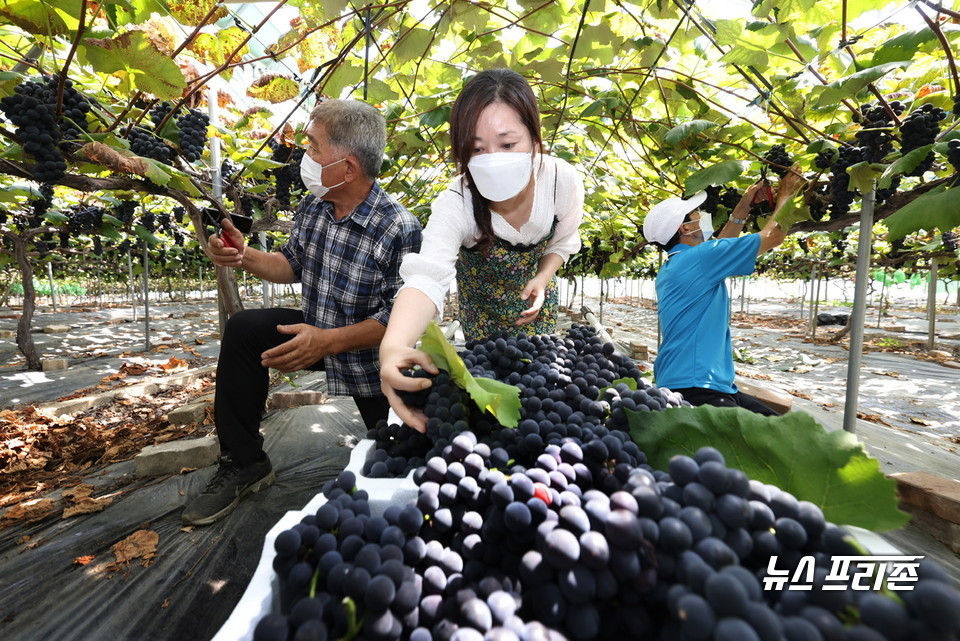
top-left (400, 191), bottom-right (472, 314)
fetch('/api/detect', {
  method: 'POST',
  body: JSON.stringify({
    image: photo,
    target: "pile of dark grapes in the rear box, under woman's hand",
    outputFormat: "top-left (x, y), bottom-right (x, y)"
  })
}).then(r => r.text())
top-left (363, 325), bottom-right (683, 482)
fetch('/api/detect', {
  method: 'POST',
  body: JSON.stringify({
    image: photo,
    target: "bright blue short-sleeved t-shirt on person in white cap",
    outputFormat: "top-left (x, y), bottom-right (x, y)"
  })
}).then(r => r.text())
top-left (653, 234), bottom-right (760, 394)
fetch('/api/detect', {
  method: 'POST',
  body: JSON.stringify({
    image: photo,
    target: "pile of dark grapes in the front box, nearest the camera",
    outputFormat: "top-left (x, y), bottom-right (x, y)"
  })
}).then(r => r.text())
top-left (254, 424), bottom-right (960, 641)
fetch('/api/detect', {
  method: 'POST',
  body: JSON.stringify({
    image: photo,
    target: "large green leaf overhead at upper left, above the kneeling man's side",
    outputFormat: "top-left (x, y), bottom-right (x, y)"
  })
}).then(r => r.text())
top-left (80, 31), bottom-right (186, 100)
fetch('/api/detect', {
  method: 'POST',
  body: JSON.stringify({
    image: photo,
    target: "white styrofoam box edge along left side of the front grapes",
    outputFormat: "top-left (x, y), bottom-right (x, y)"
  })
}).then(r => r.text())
top-left (212, 502), bottom-right (326, 641)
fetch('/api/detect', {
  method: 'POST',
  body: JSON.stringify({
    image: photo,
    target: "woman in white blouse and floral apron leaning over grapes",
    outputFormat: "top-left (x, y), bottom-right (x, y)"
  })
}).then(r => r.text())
top-left (380, 69), bottom-right (583, 431)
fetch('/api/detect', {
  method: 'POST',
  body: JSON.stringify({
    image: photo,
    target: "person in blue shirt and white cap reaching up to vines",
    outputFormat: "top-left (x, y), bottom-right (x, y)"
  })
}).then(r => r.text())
top-left (643, 171), bottom-right (803, 415)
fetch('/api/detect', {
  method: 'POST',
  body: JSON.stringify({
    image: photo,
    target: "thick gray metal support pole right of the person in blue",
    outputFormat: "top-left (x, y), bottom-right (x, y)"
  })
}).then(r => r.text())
top-left (843, 189), bottom-right (874, 434)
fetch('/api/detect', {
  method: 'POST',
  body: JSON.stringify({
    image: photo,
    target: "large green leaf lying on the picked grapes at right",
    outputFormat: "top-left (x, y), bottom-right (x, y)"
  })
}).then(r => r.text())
top-left (627, 405), bottom-right (910, 531)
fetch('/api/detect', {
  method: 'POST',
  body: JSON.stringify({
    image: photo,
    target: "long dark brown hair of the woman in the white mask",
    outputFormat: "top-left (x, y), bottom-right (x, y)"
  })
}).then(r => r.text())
top-left (450, 69), bottom-right (543, 251)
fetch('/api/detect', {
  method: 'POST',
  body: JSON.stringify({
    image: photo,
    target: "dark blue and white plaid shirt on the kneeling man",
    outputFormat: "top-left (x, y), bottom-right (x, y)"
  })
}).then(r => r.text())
top-left (280, 183), bottom-right (421, 397)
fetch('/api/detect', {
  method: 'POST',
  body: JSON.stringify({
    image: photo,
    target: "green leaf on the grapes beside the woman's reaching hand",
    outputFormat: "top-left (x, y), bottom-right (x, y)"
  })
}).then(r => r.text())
top-left (420, 321), bottom-right (520, 427)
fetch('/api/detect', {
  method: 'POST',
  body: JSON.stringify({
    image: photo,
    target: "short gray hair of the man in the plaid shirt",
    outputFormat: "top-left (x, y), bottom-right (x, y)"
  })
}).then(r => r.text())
top-left (310, 100), bottom-right (387, 180)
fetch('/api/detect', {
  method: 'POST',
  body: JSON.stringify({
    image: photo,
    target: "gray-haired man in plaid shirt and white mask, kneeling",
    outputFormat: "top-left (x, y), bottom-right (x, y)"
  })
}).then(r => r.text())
top-left (182, 100), bottom-right (421, 525)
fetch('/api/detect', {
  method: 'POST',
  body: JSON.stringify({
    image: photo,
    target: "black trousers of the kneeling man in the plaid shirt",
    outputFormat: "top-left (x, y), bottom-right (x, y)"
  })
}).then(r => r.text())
top-left (214, 308), bottom-right (390, 466)
